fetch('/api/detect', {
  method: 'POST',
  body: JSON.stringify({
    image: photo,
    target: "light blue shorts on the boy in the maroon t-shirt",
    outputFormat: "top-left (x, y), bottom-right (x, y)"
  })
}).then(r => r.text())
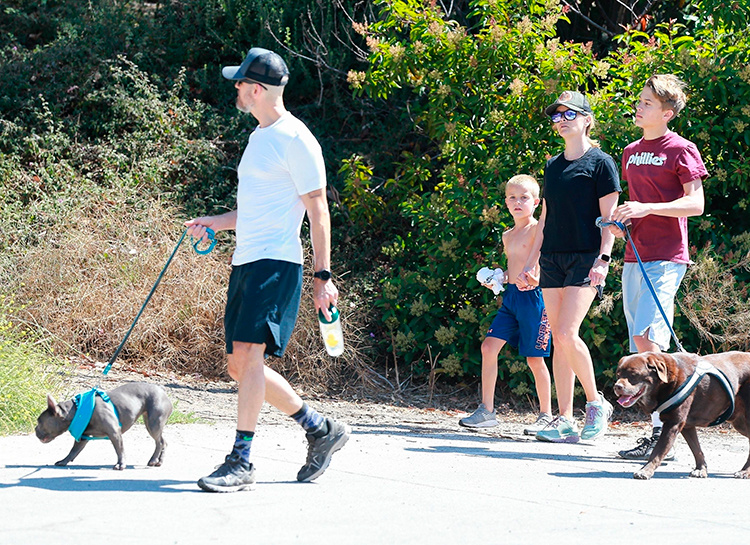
top-left (622, 261), bottom-right (687, 352)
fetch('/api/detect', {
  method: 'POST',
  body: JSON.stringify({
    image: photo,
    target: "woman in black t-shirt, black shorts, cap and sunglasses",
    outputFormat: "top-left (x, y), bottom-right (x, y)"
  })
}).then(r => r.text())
top-left (519, 91), bottom-right (621, 443)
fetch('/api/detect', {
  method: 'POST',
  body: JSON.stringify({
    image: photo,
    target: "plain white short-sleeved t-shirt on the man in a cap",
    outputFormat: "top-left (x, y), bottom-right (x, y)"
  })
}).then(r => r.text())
top-left (232, 112), bottom-right (326, 265)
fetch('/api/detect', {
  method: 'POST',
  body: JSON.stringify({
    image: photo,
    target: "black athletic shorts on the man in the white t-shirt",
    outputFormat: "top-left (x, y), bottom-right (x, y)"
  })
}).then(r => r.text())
top-left (224, 259), bottom-right (302, 356)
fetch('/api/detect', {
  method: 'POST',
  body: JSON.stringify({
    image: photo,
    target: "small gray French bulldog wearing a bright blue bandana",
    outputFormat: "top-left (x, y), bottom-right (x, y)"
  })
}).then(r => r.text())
top-left (36, 382), bottom-right (172, 470)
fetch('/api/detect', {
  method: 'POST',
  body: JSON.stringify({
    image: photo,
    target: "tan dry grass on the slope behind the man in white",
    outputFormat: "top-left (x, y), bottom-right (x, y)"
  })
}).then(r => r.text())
top-left (13, 189), bottom-right (382, 393)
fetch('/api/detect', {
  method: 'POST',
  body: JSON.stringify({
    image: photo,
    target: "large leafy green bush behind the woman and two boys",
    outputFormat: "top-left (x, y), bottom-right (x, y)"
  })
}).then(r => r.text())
top-left (344, 0), bottom-right (750, 393)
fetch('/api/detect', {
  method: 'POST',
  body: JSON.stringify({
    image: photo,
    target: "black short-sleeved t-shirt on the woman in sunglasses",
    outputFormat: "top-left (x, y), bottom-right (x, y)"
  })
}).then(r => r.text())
top-left (542, 147), bottom-right (622, 254)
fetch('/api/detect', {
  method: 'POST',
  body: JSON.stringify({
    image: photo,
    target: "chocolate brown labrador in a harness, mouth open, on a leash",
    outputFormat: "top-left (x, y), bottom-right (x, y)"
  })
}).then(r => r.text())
top-left (614, 352), bottom-right (750, 479)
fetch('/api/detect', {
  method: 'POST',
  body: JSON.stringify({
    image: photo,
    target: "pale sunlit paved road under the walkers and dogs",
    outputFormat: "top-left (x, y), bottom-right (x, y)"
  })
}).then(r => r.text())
top-left (0, 414), bottom-right (750, 545)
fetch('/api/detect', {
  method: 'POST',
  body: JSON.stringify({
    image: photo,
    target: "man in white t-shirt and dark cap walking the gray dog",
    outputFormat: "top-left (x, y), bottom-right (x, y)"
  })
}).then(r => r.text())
top-left (185, 47), bottom-right (351, 492)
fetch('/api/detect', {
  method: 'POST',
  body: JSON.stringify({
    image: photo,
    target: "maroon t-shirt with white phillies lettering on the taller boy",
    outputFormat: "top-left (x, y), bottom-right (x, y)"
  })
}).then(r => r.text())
top-left (622, 131), bottom-right (708, 263)
